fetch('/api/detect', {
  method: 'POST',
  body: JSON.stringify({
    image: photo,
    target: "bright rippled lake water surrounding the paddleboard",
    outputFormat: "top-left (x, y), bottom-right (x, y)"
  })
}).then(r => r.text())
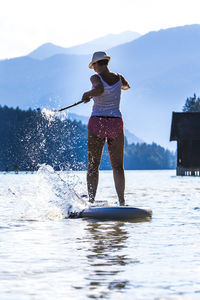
top-left (0, 166), bottom-right (200, 300)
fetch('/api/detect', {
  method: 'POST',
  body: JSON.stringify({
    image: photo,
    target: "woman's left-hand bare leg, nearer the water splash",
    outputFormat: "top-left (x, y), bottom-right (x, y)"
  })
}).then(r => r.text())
top-left (87, 132), bottom-right (105, 202)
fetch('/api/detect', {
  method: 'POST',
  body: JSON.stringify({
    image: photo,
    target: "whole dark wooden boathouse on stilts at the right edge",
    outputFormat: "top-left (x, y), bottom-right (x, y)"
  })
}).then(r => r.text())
top-left (170, 112), bottom-right (200, 176)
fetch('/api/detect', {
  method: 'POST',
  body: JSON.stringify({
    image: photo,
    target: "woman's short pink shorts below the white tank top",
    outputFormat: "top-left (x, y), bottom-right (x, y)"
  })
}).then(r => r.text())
top-left (88, 117), bottom-right (124, 139)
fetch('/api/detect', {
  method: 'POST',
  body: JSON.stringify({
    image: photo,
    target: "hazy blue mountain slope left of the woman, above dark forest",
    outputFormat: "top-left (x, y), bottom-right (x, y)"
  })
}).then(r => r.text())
top-left (0, 54), bottom-right (90, 109)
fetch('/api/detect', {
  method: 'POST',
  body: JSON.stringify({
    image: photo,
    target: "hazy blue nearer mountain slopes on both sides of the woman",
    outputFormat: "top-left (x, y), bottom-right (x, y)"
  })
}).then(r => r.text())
top-left (0, 25), bottom-right (200, 148)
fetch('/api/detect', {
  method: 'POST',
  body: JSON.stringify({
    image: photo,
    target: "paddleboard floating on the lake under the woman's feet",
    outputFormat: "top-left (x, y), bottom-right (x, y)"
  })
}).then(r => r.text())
top-left (69, 206), bottom-right (152, 221)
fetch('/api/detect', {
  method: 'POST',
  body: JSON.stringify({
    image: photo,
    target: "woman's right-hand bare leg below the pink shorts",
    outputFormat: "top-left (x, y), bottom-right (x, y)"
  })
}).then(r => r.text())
top-left (107, 133), bottom-right (125, 205)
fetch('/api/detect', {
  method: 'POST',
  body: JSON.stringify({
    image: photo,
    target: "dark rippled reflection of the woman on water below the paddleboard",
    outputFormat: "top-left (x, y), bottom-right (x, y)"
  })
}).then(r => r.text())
top-left (83, 222), bottom-right (138, 299)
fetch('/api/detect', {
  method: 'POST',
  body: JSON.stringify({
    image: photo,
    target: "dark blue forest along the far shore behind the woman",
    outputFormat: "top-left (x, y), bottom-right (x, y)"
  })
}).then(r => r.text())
top-left (0, 106), bottom-right (175, 171)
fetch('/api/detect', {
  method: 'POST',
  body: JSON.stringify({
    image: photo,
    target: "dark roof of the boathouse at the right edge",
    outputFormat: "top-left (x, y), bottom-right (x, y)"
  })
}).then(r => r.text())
top-left (170, 112), bottom-right (200, 141)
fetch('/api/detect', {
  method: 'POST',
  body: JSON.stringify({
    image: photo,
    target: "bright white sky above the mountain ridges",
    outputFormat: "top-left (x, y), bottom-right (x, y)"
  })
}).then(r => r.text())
top-left (0, 0), bottom-right (200, 59)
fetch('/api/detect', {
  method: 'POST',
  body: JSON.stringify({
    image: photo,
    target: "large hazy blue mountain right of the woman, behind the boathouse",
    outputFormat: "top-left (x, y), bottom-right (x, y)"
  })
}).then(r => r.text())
top-left (109, 25), bottom-right (200, 147)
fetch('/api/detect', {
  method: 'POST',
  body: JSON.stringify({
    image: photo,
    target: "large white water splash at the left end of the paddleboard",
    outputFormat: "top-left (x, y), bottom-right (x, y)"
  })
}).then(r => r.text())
top-left (21, 164), bottom-right (88, 220)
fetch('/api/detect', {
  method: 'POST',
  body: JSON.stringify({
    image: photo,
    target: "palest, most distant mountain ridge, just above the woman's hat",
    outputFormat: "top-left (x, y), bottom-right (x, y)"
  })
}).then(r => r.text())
top-left (28, 31), bottom-right (140, 59)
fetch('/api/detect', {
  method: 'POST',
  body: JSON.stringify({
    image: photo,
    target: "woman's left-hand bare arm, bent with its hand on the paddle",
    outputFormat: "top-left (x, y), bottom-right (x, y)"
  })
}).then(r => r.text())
top-left (82, 75), bottom-right (104, 103)
